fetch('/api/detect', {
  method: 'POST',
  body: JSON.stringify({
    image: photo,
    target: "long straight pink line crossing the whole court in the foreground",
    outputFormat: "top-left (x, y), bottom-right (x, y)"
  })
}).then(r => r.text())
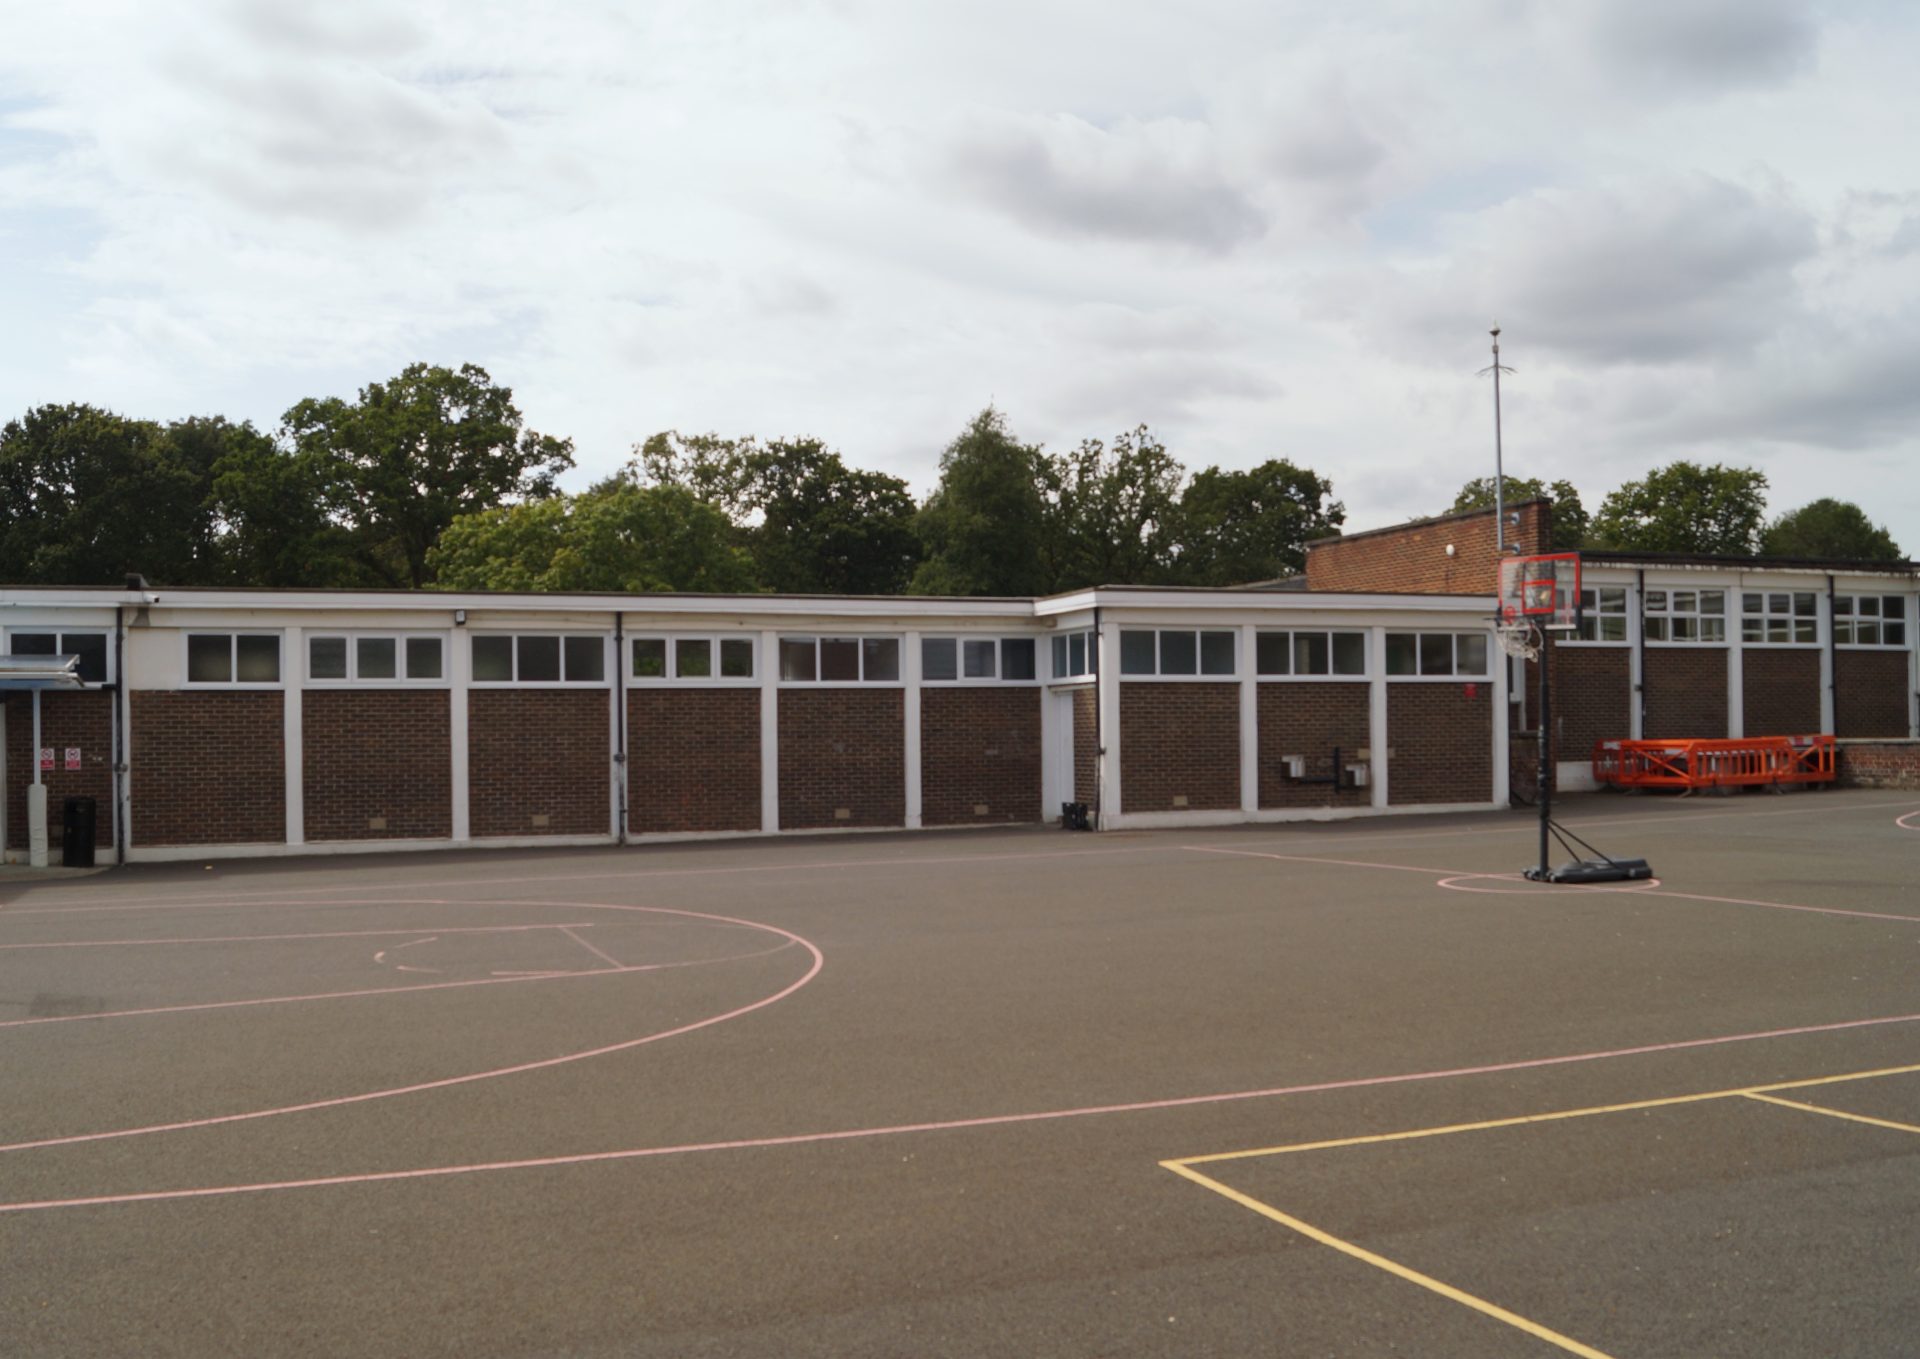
top-left (0, 1000), bottom-right (1920, 1213)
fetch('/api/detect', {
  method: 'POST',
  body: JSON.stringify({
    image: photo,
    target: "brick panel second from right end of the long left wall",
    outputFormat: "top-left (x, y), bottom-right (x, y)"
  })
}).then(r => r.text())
top-left (780, 689), bottom-right (906, 831)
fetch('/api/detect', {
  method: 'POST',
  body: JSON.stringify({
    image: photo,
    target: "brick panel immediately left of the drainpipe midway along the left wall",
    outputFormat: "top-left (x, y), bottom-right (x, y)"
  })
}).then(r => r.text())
top-left (467, 689), bottom-right (612, 837)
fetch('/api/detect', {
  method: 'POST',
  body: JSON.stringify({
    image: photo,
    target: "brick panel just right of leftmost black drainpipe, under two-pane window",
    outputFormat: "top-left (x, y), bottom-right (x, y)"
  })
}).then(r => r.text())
top-left (127, 689), bottom-right (286, 845)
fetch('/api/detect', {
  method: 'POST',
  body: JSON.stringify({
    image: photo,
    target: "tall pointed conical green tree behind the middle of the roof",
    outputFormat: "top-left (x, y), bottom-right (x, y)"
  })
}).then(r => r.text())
top-left (910, 407), bottom-right (1048, 595)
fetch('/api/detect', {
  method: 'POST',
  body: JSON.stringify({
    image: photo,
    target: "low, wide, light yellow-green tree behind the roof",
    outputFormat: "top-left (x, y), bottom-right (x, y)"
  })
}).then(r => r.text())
top-left (428, 480), bottom-right (756, 595)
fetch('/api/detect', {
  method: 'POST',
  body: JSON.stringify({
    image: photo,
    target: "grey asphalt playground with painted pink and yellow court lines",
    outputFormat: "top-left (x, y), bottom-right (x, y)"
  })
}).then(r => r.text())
top-left (0, 791), bottom-right (1920, 1359)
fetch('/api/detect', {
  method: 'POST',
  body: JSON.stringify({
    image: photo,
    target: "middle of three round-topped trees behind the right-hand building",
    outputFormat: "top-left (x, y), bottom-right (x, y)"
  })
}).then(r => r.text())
top-left (1592, 461), bottom-right (1766, 557)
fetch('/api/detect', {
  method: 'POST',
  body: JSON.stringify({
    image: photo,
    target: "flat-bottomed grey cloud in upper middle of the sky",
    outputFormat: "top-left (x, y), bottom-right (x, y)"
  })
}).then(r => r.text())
top-left (947, 115), bottom-right (1265, 253)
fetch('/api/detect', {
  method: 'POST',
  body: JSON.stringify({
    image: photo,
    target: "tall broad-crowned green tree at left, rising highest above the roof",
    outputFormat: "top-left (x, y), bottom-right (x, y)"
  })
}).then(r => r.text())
top-left (284, 363), bottom-right (574, 587)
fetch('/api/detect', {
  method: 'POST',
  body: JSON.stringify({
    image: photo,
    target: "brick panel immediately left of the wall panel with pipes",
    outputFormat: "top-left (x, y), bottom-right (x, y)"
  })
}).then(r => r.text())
top-left (1119, 681), bottom-right (1240, 812)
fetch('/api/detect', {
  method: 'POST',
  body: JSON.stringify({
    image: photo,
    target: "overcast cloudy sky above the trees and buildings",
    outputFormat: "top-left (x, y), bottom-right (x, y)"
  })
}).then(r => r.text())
top-left (0, 0), bottom-right (1920, 555)
